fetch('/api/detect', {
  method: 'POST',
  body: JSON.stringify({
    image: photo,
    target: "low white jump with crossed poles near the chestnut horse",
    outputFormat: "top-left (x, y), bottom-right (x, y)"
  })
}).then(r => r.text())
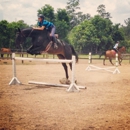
top-left (86, 52), bottom-right (120, 74)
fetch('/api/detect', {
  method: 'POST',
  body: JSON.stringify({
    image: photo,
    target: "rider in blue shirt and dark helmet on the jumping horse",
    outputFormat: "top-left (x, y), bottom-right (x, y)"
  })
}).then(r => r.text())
top-left (33, 14), bottom-right (58, 49)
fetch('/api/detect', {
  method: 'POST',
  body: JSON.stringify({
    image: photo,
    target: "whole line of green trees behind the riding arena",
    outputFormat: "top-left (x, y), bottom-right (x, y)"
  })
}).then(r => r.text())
top-left (0, 0), bottom-right (130, 53)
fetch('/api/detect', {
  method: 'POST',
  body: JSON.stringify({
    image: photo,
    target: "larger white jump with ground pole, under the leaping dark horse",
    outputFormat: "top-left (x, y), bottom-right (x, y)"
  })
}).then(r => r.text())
top-left (9, 53), bottom-right (86, 92)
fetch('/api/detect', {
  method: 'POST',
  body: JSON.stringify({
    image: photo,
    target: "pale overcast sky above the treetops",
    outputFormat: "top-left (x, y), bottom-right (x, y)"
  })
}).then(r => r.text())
top-left (0, 0), bottom-right (130, 25)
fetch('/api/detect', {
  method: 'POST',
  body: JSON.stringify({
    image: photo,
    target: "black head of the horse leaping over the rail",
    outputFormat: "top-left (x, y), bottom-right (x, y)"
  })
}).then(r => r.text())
top-left (15, 28), bottom-right (26, 49)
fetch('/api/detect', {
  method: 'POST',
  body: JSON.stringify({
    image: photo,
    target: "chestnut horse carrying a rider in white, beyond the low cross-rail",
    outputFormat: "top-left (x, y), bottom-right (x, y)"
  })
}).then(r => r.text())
top-left (99, 46), bottom-right (126, 65)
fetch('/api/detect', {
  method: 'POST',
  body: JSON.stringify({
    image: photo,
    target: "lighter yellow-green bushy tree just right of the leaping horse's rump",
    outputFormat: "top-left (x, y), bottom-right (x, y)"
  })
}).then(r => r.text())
top-left (68, 20), bottom-right (100, 52)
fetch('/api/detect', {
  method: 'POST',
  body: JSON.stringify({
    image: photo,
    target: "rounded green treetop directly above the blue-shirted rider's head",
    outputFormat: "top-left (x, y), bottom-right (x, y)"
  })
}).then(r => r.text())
top-left (37, 4), bottom-right (55, 22)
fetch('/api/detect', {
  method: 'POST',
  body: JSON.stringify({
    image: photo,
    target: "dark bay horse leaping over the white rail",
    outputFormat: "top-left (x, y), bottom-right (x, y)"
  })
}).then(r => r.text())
top-left (16, 28), bottom-right (78, 79)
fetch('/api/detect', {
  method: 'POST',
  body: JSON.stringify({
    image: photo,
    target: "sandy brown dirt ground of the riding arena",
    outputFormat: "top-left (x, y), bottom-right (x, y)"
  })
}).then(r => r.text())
top-left (0, 60), bottom-right (130, 130)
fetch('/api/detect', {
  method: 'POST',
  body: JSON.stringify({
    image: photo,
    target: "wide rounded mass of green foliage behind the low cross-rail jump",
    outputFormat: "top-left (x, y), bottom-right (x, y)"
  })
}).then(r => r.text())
top-left (68, 15), bottom-right (124, 52)
